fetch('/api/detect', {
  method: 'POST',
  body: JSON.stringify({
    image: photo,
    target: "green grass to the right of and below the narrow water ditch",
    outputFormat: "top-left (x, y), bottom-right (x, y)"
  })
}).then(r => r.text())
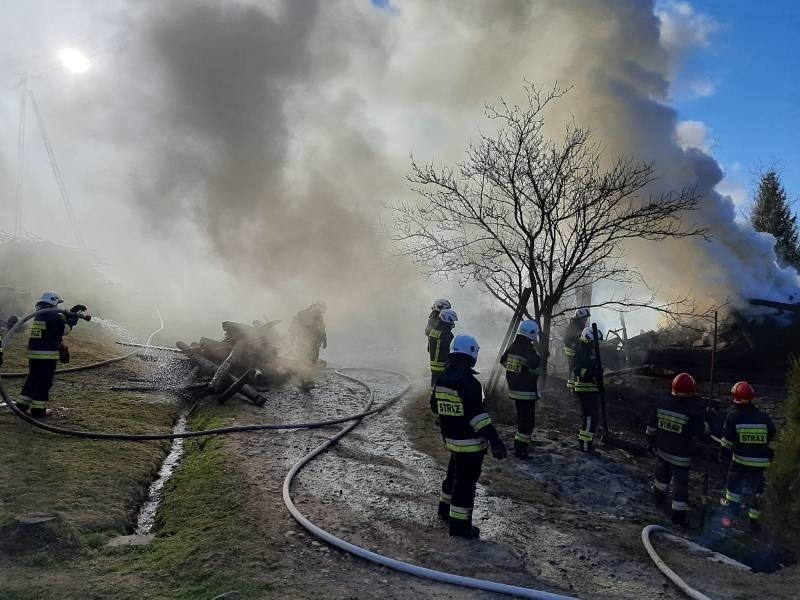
top-left (0, 405), bottom-right (270, 600)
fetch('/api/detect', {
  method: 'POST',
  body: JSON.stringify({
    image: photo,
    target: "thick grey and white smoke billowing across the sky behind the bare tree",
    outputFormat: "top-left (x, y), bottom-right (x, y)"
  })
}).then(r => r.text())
top-left (0, 0), bottom-right (797, 364)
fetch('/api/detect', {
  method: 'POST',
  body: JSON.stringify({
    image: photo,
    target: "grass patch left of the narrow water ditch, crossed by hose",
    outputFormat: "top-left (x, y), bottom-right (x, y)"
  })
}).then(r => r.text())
top-left (0, 384), bottom-right (175, 533)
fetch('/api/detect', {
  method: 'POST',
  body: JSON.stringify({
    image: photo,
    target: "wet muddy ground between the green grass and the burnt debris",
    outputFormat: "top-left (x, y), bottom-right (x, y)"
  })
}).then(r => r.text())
top-left (227, 371), bottom-right (797, 598)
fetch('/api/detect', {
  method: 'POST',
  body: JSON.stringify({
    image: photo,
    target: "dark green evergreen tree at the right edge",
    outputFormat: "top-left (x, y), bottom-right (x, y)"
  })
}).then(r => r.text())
top-left (750, 171), bottom-right (800, 270)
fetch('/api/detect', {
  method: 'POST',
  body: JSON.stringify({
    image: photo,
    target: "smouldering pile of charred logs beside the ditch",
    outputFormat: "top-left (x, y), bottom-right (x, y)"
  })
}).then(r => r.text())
top-left (176, 321), bottom-right (298, 406)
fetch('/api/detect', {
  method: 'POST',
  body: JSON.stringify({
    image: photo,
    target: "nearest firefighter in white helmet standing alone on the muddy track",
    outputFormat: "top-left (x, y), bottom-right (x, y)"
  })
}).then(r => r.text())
top-left (431, 335), bottom-right (506, 538)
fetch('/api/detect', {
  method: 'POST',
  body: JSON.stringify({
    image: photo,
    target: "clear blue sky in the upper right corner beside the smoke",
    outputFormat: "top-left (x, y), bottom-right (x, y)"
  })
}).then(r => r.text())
top-left (673, 0), bottom-right (800, 210)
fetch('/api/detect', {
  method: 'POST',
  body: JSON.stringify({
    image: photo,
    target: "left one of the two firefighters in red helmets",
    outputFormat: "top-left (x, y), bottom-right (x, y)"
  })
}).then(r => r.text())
top-left (645, 373), bottom-right (709, 525)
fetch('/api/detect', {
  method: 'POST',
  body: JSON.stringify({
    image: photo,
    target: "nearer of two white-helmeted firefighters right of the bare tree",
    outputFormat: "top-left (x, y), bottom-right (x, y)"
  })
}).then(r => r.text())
top-left (572, 327), bottom-right (603, 452)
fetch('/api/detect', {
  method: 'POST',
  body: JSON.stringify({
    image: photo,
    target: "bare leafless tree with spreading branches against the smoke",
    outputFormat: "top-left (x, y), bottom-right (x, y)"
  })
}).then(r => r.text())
top-left (390, 83), bottom-right (705, 372)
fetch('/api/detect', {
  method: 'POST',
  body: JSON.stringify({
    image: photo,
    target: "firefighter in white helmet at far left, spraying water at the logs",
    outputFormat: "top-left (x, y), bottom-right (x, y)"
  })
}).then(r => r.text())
top-left (17, 292), bottom-right (86, 419)
